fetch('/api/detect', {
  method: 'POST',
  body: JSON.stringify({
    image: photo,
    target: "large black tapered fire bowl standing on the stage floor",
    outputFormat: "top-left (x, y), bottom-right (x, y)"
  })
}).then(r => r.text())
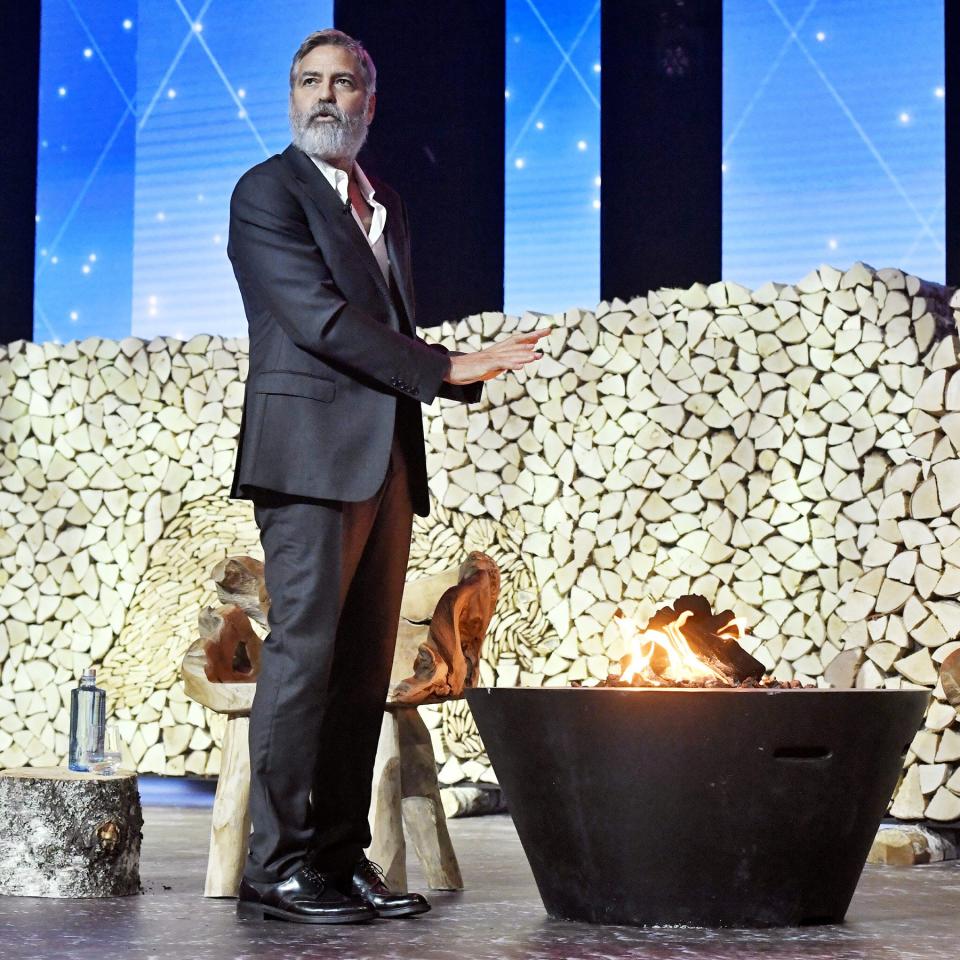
top-left (467, 687), bottom-right (929, 927)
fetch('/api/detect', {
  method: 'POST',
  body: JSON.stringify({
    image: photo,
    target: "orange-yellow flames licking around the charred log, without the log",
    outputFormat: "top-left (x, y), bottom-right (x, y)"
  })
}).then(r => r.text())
top-left (616, 610), bottom-right (728, 685)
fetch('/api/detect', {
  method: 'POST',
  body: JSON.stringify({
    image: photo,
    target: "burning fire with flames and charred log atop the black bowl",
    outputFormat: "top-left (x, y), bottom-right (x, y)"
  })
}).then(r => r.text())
top-left (614, 597), bottom-right (762, 686)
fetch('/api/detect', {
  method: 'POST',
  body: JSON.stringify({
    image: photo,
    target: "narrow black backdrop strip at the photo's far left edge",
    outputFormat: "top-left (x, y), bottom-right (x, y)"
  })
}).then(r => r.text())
top-left (0, 3), bottom-right (40, 343)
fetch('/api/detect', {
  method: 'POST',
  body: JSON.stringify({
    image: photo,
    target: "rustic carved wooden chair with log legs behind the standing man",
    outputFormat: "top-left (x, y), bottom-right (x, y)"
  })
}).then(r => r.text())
top-left (181, 552), bottom-right (500, 897)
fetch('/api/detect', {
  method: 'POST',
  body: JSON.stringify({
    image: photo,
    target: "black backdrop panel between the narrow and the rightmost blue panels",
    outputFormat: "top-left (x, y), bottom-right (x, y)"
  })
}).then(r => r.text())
top-left (600, 0), bottom-right (723, 299)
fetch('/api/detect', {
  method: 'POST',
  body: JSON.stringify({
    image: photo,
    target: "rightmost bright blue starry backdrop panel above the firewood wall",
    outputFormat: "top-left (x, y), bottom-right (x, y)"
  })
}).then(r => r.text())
top-left (723, 0), bottom-right (945, 286)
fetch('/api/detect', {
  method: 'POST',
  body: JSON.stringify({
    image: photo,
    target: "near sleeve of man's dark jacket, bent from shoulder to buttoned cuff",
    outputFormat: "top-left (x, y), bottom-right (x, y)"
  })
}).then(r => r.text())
top-left (228, 175), bottom-right (450, 403)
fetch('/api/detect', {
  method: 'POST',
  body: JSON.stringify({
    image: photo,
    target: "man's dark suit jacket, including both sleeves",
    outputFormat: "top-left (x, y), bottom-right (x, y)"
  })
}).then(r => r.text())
top-left (227, 145), bottom-right (482, 516)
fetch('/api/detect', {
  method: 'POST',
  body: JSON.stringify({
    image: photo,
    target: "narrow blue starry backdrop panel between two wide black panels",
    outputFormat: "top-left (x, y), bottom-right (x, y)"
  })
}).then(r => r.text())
top-left (504, 0), bottom-right (600, 312)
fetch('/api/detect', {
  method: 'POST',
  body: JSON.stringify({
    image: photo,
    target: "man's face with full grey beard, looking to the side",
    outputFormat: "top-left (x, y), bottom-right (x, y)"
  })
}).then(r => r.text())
top-left (290, 44), bottom-right (376, 161)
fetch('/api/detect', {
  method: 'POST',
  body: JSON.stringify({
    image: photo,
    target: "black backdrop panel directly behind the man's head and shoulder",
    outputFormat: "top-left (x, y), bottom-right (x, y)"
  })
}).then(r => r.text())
top-left (334, 0), bottom-right (505, 326)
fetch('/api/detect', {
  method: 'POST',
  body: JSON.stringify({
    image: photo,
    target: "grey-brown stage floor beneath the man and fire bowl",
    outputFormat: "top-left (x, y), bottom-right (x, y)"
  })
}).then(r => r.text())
top-left (0, 807), bottom-right (960, 960)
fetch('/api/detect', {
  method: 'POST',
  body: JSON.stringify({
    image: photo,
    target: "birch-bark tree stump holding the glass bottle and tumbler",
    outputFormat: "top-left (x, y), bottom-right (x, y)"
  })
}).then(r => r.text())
top-left (0, 767), bottom-right (143, 897)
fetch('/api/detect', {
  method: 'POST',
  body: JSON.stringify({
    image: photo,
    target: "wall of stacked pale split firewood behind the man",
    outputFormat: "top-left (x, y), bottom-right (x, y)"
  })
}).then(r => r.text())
top-left (0, 264), bottom-right (960, 820)
